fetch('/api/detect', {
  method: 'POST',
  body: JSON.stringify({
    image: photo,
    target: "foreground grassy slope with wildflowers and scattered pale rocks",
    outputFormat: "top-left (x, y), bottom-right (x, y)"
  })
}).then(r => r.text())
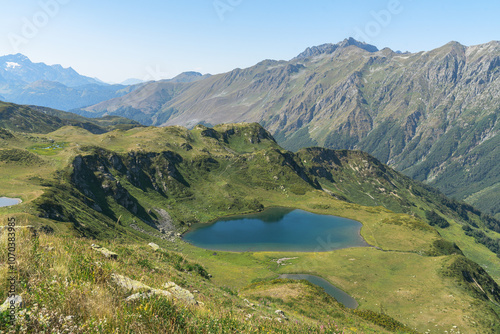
top-left (0, 231), bottom-right (404, 334)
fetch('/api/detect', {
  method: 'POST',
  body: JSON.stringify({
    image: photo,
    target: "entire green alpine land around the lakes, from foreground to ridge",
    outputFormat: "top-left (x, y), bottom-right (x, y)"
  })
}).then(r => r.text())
top-left (0, 109), bottom-right (500, 333)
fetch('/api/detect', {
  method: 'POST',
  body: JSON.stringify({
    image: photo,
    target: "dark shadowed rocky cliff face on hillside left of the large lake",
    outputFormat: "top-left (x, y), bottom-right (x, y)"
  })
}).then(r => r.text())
top-left (69, 148), bottom-right (189, 236)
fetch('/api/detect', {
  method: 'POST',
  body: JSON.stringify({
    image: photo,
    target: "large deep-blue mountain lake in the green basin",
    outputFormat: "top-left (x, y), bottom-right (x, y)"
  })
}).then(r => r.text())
top-left (183, 208), bottom-right (368, 252)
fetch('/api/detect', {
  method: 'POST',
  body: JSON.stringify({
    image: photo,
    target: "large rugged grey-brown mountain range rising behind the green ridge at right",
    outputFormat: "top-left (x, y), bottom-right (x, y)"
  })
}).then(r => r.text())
top-left (76, 39), bottom-right (500, 215)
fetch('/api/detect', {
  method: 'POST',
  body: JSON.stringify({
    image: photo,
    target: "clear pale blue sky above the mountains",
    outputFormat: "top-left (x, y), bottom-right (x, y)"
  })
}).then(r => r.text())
top-left (0, 0), bottom-right (500, 82)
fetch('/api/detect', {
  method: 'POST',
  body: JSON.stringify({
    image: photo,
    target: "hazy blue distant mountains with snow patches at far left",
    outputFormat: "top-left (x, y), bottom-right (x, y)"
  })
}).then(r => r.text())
top-left (0, 54), bottom-right (206, 111)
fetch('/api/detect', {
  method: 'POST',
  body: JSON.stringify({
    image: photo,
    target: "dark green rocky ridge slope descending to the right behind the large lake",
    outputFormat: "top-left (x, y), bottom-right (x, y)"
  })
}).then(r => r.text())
top-left (298, 148), bottom-right (500, 282)
